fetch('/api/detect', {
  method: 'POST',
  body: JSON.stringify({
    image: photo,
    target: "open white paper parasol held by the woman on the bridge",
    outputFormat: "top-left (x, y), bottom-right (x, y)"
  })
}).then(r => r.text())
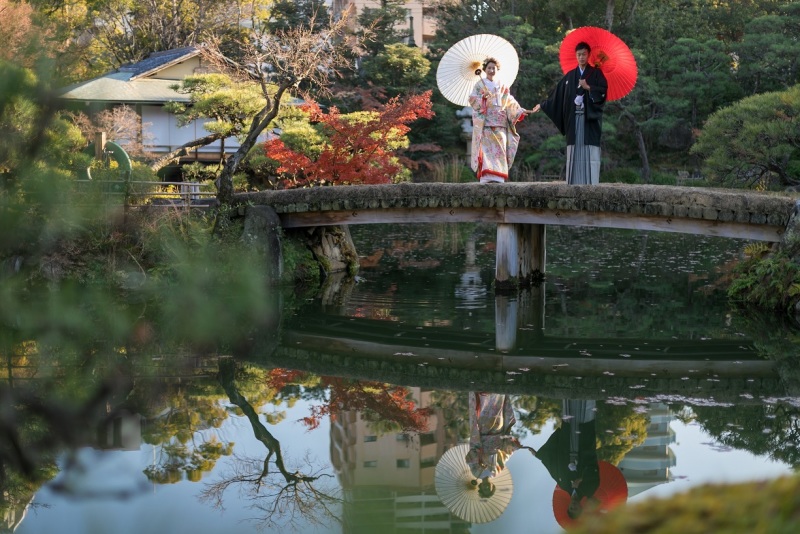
top-left (436, 33), bottom-right (519, 106)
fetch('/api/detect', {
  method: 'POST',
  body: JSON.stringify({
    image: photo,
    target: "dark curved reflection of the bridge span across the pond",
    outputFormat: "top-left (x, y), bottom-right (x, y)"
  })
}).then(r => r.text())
top-left (258, 315), bottom-right (791, 403)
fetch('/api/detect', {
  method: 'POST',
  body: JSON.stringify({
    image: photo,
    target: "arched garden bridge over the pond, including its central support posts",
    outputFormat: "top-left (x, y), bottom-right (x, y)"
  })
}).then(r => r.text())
top-left (235, 182), bottom-right (796, 285)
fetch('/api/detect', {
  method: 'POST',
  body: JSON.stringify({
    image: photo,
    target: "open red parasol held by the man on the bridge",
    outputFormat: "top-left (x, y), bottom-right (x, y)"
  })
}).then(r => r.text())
top-left (558, 26), bottom-right (638, 101)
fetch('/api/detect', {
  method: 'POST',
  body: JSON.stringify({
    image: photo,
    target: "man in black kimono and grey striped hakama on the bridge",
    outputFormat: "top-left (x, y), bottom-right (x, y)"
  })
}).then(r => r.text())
top-left (532, 42), bottom-right (608, 184)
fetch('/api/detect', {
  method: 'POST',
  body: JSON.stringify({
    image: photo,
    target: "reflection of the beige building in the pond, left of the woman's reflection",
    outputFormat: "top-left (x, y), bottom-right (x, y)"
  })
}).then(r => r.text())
top-left (331, 388), bottom-right (469, 534)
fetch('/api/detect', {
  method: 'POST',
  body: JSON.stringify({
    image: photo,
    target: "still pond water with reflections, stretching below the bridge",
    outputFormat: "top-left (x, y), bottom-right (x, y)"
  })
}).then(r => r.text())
top-left (0, 225), bottom-right (800, 534)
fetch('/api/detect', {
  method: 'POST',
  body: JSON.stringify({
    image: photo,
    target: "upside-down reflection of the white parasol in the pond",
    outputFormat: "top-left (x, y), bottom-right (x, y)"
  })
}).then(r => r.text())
top-left (434, 443), bottom-right (514, 523)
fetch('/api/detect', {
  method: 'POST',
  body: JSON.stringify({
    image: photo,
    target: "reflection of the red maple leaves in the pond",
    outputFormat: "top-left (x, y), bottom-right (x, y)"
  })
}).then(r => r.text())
top-left (267, 369), bottom-right (432, 432)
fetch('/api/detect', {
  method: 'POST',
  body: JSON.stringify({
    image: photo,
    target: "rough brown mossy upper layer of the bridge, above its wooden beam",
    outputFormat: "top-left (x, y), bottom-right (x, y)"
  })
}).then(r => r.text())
top-left (236, 182), bottom-right (794, 228)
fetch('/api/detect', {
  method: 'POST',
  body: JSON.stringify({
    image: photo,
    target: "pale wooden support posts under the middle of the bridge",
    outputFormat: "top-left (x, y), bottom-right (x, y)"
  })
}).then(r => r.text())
top-left (494, 223), bottom-right (547, 291)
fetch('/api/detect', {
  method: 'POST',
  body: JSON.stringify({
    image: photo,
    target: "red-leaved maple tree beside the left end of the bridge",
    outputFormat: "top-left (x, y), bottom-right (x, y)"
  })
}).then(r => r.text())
top-left (264, 91), bottom-right (433, 187)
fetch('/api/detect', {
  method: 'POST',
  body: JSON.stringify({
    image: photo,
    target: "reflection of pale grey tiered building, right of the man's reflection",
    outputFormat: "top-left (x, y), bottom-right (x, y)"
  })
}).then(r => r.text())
top-left (618, 403), bottom-right (675, 497)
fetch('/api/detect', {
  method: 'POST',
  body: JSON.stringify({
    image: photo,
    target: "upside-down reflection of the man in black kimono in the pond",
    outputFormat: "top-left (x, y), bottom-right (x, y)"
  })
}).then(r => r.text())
top-left (534, 400), bottom-right (600, 519)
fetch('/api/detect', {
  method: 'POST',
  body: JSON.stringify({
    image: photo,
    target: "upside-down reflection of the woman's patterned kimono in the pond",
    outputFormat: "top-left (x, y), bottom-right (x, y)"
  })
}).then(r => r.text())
top-left (465, 391), bottom-right (521, 492)
